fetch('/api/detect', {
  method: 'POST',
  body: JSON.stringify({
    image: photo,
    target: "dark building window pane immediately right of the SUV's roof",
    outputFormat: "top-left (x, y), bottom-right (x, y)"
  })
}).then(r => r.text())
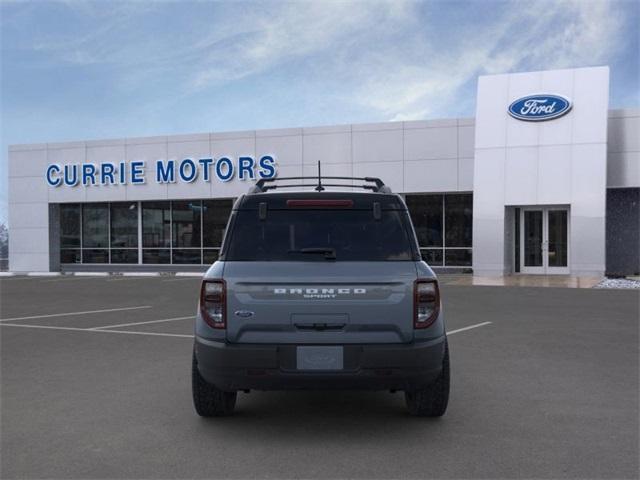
top-left (405, 195), bottom-right (442, 247)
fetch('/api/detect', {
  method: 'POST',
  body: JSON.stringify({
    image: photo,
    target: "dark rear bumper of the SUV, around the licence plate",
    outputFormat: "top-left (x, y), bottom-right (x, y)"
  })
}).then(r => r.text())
top-left (195, 336), bottom-right (446, 391)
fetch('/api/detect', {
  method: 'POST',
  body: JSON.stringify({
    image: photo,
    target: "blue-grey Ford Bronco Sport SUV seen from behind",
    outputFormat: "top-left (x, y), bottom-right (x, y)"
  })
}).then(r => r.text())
top-left (192, 175), bottom-right (449, 417)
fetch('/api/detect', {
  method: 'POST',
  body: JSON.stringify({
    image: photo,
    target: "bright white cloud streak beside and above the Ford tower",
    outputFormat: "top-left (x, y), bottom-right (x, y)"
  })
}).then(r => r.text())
top-left (348, 1), bottom-right (623, 120)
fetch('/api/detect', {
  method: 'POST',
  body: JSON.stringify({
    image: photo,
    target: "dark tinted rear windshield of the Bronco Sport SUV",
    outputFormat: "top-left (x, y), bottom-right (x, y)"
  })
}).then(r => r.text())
top-left (224, 209), bottom-right (414, 261)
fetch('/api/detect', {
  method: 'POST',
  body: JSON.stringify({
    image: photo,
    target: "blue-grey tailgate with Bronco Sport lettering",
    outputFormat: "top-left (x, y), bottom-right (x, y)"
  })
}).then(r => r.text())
top-left (224, 261), bottom-right (416, 344)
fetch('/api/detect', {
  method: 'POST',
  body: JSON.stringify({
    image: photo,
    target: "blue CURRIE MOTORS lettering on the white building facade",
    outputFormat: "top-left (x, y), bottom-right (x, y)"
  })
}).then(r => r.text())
top-left (45, 155), bottom-right (276, 187)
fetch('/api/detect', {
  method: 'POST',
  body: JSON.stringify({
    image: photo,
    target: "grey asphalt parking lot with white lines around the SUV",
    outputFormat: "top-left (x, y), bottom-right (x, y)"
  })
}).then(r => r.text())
top-left (0, 277), bottom-right (640, 478)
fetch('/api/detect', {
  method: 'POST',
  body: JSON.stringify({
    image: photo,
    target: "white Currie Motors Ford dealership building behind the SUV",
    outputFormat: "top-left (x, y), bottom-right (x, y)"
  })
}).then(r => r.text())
top-left (9, 67), bottom-right (640, 276)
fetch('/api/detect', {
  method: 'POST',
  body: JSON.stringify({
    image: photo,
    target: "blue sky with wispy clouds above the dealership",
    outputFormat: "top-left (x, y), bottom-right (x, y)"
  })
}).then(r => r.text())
top-left (0, 0), bottom-right (640, 225)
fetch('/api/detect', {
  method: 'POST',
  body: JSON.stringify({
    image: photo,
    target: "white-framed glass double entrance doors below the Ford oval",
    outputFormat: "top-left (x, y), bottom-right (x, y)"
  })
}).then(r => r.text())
top-left (520, 207), bottom-right (569, 274)
